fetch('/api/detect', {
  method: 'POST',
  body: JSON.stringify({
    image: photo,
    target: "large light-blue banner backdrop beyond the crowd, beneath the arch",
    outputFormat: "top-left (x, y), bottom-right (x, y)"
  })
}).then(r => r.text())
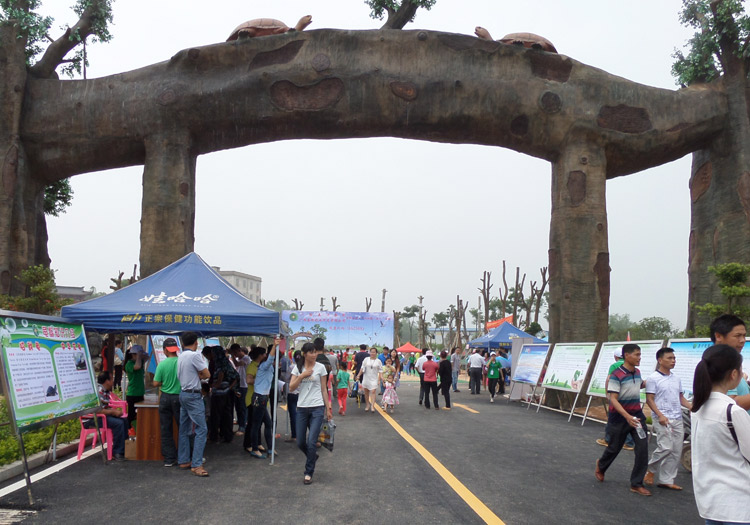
top-left (281, 310), bottom-right (393, 350)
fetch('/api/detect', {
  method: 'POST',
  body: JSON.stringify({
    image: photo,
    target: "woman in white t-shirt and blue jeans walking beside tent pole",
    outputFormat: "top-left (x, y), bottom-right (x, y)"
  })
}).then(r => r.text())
top-left (289, 343), bottom-right (333, 485)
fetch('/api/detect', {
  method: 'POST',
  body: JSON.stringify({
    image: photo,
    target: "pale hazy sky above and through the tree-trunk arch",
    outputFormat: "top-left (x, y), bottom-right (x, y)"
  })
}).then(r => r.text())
top-left (44, 0), bottom-right (690, 328)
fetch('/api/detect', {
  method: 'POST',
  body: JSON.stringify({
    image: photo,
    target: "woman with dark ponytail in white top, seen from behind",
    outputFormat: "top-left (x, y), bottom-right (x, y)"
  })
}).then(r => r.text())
top-left (692, 345), bottom-right (750, 525)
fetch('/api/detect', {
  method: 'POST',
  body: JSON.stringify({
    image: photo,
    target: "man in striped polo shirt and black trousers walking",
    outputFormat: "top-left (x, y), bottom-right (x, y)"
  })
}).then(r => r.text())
top-left (594, 343), bottom-right (651, 496)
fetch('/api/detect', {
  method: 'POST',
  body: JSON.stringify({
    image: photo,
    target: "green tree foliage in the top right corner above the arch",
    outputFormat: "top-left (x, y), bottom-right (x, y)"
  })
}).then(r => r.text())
top-left (672, 0), bottom-right (750, 86)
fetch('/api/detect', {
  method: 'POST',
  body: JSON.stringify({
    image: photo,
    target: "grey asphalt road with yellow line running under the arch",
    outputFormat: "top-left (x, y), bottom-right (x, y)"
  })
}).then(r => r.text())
top-left (0, 376), bottom-right (703, 525)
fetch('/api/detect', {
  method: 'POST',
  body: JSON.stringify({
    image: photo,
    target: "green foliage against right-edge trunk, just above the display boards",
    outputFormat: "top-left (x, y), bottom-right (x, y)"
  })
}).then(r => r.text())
top-left (691, 262), bottom-right (750, 336)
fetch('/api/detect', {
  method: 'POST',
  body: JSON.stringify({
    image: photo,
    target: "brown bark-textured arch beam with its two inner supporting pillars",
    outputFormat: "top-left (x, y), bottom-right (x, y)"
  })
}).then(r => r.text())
top-left (0, 30), bottom-right (750, 340)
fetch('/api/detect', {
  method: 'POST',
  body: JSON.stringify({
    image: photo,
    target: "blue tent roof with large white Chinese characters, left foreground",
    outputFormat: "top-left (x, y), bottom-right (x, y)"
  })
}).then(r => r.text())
top-left (62, 253), bottom-right (280, 336)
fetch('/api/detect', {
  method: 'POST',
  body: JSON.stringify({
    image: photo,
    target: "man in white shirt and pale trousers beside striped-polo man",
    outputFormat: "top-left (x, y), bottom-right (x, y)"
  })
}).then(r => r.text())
top-left (643, 348), bottom-right (693, 490)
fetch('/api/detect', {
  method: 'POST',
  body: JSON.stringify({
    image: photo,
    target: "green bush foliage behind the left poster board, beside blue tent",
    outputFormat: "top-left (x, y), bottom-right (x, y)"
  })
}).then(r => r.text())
top-left (0, 264), bottom-right (71, 315)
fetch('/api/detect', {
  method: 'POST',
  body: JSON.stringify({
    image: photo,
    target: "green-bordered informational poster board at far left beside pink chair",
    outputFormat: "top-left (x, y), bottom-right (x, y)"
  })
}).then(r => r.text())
top-left (0, 311), bottom-right (99, 431)
